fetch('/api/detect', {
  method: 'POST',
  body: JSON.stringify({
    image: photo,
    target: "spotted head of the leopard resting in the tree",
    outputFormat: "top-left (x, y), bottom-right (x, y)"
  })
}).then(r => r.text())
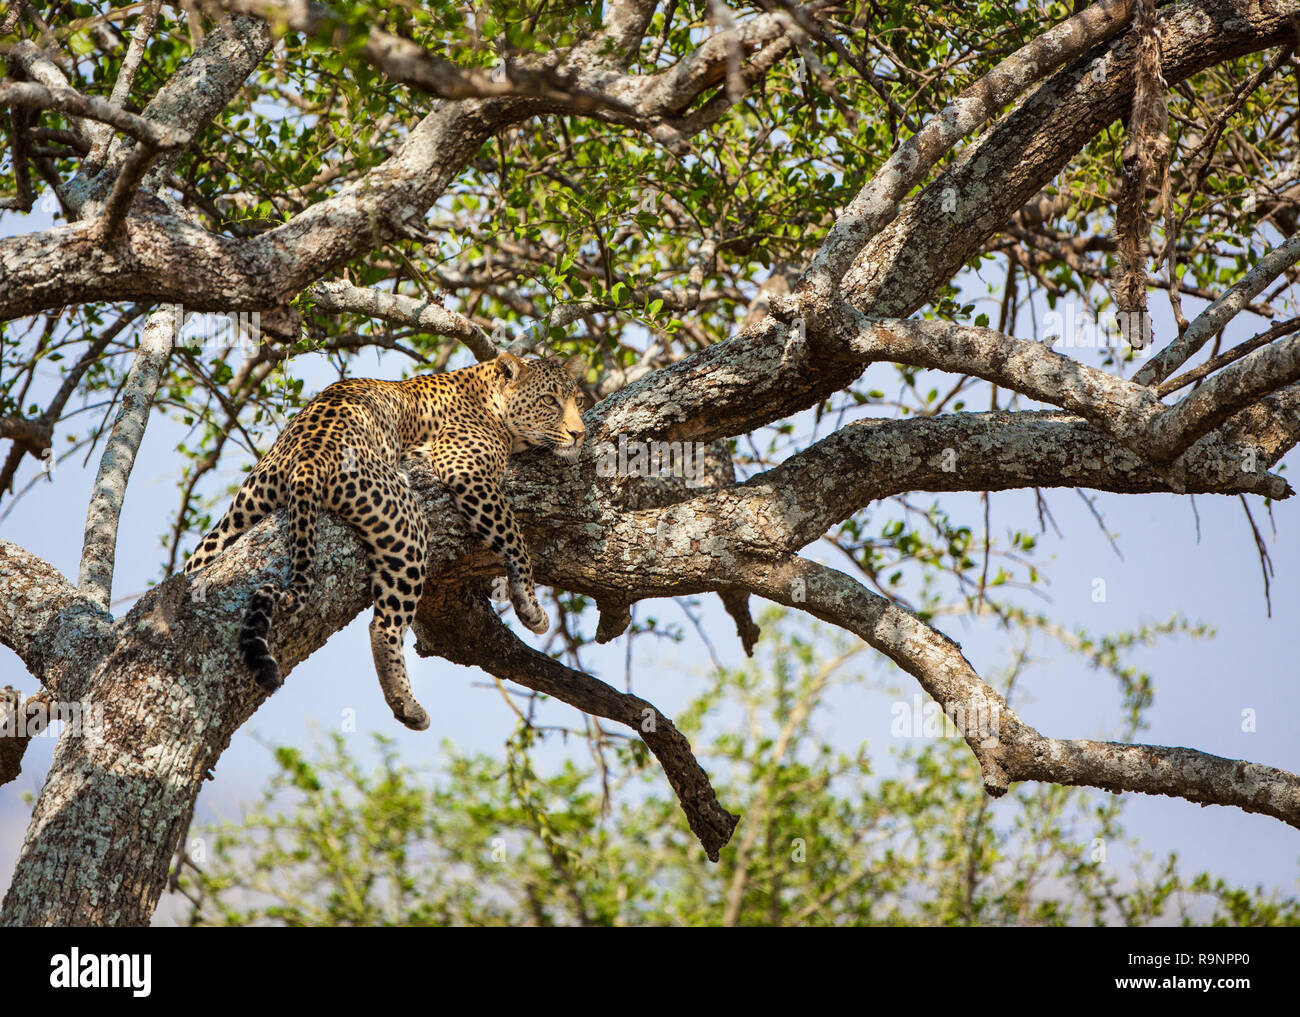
top-left (495, 352), bottom-right (586, 459)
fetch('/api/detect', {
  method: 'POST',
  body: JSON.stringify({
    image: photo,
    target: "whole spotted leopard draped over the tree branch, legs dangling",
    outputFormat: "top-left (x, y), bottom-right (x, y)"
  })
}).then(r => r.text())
top-left (183, 351), bottom-right (586, 731)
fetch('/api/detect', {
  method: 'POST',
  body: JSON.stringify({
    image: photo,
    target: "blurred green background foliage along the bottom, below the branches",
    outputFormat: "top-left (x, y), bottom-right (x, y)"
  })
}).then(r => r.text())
top-left (176, 613), bottom-right (1300, 926)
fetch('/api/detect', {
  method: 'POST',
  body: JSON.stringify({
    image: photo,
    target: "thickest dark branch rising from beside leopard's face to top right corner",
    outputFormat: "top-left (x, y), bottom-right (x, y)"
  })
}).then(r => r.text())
top-left (593, 0), bottom-right (1300, 455)
